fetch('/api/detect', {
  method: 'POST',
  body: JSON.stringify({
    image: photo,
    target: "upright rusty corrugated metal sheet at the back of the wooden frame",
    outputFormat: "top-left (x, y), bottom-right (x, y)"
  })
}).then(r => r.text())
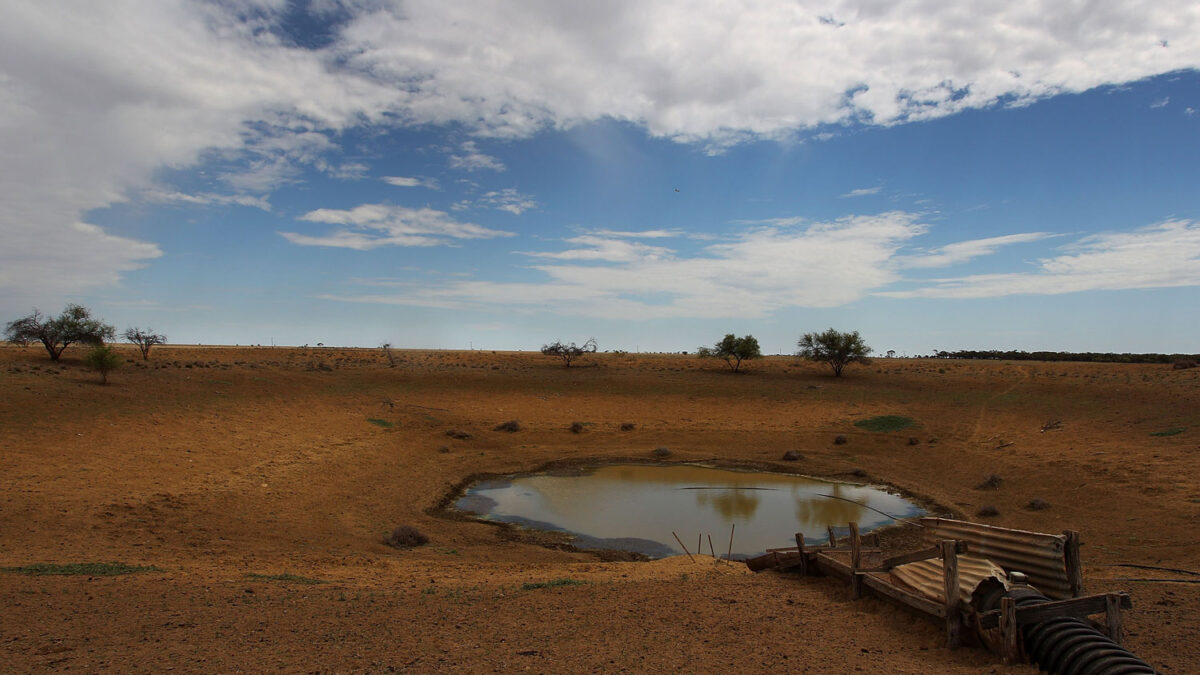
top-left (920, 518), bottom-right (1073, 598)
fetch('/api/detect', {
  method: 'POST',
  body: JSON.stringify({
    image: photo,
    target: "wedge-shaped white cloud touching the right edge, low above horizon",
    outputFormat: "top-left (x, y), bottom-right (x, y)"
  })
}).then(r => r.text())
top-left (878, 220), bottom-right (1200, 298)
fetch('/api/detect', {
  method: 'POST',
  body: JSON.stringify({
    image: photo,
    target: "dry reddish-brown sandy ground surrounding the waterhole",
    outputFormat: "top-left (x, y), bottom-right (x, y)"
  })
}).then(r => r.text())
top-left (0, 346), bottom-right (1200, 673)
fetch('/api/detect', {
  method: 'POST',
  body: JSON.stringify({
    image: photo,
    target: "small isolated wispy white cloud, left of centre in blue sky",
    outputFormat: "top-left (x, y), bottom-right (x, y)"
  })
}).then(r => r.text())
top-left (280, 204), bottom-right (512, 251)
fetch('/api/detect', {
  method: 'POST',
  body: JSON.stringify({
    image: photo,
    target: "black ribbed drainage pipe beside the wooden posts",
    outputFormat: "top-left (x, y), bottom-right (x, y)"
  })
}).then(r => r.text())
top-left (994, 589), bottom-right (1156, 675)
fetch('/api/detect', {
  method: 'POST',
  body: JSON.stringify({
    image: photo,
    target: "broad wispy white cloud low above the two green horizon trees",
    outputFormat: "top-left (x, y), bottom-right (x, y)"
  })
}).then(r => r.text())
top-left (324, 213), bottom-right (925, 319)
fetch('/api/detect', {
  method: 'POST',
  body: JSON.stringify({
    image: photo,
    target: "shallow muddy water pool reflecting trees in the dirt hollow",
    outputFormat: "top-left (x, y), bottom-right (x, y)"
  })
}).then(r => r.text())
top-left (455, 465), bottom-right (923, 557)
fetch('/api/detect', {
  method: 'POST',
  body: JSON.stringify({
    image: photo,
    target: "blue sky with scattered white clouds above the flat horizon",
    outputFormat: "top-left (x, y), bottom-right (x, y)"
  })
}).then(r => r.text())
top-left (0, 0), bottom-right (1200, 356)
